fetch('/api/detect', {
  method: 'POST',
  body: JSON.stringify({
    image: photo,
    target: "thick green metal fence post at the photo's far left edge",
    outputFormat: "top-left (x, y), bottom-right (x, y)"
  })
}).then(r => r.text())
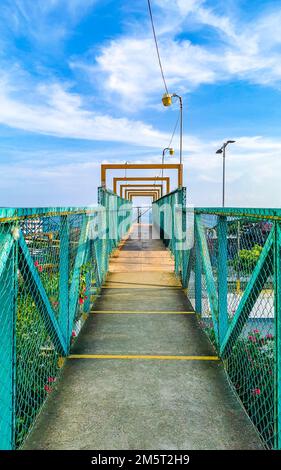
top-left (0, 225), bottom-right (17, 450)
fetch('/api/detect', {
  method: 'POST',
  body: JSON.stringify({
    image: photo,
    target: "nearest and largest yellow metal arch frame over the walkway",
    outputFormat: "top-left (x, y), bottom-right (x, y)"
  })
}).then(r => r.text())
top-left (101, 163), bottom-right (183, 188)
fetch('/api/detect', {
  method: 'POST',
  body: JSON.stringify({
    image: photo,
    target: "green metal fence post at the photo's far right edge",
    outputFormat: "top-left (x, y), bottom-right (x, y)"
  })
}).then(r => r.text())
top-left (274, 221), bottom-right (281, 450)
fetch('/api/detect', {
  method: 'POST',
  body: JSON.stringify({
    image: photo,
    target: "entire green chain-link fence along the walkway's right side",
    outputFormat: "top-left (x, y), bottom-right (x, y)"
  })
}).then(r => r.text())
top-left (154, 194), bottom-right (281, 449)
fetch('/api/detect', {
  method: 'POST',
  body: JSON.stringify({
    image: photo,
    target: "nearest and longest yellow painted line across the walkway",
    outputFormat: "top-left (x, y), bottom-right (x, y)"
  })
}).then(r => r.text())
top-left (68, 354), bottom-right (220, 361)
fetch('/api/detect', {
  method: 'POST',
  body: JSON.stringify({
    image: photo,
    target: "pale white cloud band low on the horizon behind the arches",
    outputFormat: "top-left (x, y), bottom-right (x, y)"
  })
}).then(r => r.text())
top-left (0, 132), bottom-right (281, 207)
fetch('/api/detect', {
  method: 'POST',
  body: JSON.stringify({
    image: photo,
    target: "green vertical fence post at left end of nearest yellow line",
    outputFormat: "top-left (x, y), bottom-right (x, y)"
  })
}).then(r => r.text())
top-left (59, 215), bottom-right (70, 348)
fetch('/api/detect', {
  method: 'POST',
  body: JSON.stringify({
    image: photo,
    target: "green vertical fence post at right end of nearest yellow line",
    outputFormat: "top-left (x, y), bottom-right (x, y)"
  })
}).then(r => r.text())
top-left (218, 216), bottom-right (228, 346)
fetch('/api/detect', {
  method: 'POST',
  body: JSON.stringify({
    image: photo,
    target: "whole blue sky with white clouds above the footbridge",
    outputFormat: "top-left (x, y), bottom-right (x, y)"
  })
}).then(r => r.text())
top-left (0, 0), bottom-right (281, 207)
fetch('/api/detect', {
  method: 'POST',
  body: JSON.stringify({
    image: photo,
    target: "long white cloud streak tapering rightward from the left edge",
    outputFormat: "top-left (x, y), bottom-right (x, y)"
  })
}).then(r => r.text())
top-left (0, 73), bottom-right (173, 147)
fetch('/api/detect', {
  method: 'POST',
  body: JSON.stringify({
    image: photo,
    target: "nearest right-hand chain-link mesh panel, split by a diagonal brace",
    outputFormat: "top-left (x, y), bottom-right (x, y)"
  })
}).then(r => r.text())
top-left (225, 218), bottom-right (275, 448)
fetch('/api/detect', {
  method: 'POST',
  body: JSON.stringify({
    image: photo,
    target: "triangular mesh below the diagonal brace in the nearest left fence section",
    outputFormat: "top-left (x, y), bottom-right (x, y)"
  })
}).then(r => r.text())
top-left (15, 275), bottom-right (60, 447)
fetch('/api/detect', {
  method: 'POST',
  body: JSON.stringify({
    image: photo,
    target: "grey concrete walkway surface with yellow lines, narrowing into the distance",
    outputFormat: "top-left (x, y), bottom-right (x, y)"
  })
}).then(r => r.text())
top-left (25, 227), bottom-right (262, 450)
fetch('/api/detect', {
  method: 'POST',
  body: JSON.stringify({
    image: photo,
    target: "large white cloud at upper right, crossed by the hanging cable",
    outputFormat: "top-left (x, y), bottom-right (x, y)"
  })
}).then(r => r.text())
top-left (75, 0), bottom-right (281, 111)
